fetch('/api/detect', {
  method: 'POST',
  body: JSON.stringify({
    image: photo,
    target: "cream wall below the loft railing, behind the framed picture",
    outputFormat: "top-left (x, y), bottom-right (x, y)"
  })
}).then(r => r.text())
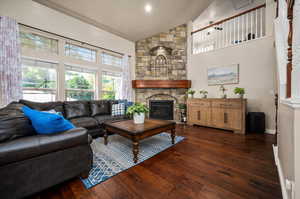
top-left (187, 0), bottom-right (277, 132)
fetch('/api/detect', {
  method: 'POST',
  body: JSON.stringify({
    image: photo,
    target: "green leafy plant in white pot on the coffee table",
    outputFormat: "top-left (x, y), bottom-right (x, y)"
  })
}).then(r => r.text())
top-left (126, 103), bottom-right (149, 124)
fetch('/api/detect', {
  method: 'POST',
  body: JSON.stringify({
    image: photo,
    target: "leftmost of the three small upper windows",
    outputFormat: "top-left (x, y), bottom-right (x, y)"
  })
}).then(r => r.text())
top-left (20, 32), bottom-right (58, 54)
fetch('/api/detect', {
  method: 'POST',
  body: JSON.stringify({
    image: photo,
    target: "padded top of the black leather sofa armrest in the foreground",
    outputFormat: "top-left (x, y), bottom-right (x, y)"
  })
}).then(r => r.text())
top-left (0, 128), bottom-right (90, 166)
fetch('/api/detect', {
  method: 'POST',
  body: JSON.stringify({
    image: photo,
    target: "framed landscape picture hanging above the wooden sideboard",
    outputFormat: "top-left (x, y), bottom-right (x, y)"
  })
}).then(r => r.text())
top-left (207, 64), bottom-right (239, 86)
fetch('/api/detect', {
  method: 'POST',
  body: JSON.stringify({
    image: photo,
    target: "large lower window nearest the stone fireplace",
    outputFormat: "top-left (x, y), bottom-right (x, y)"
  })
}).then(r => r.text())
top-left (101, 71), bottom-right (122, 99)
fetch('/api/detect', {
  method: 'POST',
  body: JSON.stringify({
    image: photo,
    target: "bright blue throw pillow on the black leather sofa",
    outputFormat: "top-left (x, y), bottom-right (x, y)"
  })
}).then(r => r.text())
top-left (22, 106), bottom-right (75, 134)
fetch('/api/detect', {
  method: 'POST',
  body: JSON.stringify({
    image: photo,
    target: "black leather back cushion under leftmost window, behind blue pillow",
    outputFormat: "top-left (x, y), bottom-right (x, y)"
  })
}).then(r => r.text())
top-left (19, 99), bottom-right (64, 113)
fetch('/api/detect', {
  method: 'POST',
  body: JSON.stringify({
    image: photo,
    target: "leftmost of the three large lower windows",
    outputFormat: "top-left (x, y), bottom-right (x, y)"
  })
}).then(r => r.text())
top-left (22, 58), bottom-right (57, 102)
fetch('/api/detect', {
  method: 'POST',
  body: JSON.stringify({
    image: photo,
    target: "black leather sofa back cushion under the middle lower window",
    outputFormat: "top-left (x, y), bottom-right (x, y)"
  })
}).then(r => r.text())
top-left (64, 101), bottom-right (90, 119)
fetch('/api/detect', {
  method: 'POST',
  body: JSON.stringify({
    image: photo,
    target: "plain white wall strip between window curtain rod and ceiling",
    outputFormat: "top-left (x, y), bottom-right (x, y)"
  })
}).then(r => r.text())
top-left (0, 0), bottom-right (134, 55)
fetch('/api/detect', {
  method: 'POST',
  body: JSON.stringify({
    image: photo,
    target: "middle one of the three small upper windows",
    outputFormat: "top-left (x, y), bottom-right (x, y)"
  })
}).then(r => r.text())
top-left (65, 43), bottom-right (96, 62)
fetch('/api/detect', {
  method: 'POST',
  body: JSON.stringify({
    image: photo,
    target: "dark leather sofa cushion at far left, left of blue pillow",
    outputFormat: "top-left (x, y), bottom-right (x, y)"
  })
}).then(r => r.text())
top-left (0, 102), bottom-right (36, 143)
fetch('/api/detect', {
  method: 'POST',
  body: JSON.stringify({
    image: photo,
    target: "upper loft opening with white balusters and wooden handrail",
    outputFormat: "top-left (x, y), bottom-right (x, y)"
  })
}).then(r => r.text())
top-left (192, 0), bottom-right (266, 54)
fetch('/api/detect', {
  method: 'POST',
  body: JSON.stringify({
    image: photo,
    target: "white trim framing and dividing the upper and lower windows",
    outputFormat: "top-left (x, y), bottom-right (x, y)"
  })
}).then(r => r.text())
top-left (20, 26), bottom-right (127, 101)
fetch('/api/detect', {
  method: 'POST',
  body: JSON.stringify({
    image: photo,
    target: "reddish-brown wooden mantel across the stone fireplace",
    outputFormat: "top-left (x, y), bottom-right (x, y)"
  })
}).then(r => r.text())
top-left (132, 80), bottom-right (192, 88)
